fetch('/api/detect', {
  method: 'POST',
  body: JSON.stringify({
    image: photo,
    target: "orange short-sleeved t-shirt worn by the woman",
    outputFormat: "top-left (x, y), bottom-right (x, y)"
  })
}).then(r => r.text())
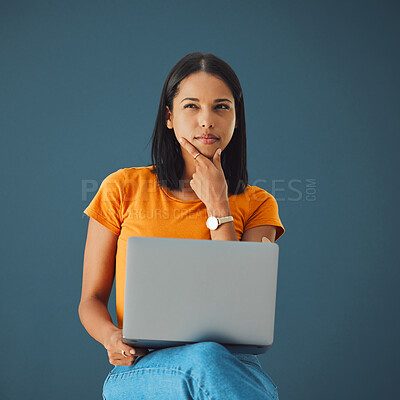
top-left (84, 166), bottom-right (285, 328)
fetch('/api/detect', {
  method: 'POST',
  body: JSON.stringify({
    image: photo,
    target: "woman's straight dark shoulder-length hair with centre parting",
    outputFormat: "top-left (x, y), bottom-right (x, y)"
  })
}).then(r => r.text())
top-left (151, 52), bottom-right (248, 194)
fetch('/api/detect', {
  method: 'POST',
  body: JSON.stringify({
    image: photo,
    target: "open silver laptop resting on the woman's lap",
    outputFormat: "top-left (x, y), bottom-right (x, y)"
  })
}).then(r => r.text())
top-left (123, 236), bottom-right (279, 354)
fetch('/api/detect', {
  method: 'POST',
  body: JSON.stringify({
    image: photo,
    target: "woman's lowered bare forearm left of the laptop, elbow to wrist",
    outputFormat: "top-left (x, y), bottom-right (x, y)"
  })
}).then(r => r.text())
top-left (78, 297), bottom-right (118, 347)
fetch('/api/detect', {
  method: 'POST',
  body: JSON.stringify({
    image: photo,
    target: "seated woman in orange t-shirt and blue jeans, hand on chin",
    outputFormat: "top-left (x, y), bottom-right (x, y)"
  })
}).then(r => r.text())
top-left (79, 52), bottom-right (284, 400)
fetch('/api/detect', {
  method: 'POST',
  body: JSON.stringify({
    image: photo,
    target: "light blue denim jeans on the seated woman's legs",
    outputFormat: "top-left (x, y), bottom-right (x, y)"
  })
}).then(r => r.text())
top-left (103, 342), bottom-right (278, 400)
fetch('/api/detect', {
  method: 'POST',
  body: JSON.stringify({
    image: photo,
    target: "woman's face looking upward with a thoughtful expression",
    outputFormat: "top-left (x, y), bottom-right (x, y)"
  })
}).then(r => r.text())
top-left (166, 71), bottom-right (236, 158)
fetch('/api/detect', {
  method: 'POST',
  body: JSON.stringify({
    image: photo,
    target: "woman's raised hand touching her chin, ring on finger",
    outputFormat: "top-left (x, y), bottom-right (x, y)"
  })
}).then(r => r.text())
top-left (180, 137), bottom-right (228, 207)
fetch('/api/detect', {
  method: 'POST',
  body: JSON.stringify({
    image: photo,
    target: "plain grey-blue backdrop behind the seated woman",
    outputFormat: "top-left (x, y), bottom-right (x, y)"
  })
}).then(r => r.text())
top-left (0, 0), bottom-right (400, 400)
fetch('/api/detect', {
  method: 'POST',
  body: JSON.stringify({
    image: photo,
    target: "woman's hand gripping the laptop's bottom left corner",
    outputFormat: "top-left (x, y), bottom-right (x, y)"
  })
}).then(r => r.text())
top-left (104, 328), bottom-right (149, 366)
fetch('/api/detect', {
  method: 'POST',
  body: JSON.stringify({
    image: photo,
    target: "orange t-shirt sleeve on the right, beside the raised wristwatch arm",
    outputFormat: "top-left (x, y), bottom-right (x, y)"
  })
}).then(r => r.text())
top-left (244, 186), bottom-right (285, 242)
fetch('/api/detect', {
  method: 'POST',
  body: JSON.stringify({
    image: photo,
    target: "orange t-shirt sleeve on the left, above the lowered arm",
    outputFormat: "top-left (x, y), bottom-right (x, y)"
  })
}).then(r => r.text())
top-left (83, 169), bottom-right (124, 235)
